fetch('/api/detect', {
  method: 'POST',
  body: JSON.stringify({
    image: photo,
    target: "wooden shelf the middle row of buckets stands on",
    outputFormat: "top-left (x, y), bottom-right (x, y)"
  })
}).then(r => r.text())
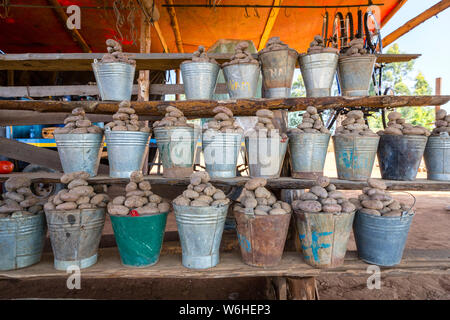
top-left (0, 172), bottom-right (450, 191)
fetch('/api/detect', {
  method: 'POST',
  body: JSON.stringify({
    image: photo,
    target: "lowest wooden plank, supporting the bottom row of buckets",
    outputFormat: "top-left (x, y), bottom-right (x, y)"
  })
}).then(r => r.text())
top-left (0, 248), bottom-right (450, 280)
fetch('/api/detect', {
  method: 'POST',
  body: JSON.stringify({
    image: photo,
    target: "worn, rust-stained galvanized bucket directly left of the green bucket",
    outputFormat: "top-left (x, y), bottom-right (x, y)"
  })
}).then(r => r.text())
top-left (45, 208), bottom-right (105, 271)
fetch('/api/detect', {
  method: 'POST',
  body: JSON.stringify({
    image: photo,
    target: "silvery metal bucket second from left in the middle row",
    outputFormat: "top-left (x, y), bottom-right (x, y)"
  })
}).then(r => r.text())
top-left (105, 131), bottom-right (150, 178)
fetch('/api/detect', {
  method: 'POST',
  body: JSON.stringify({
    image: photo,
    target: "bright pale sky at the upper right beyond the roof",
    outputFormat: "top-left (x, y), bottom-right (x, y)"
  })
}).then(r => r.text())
top-left (381, 0), bottom-right (450, 111)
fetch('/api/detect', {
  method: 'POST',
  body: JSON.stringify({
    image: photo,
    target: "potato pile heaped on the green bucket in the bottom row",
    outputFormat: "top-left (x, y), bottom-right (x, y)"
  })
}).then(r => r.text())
top-left (108, 171), bottom-right (170, 216)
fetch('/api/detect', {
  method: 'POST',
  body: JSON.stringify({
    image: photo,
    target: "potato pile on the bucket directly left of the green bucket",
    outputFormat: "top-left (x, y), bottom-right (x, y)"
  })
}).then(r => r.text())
top-left (44, 171), bottom-right (109, 210)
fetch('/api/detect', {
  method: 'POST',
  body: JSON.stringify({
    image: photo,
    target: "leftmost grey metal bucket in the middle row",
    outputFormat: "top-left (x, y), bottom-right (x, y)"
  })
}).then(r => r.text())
top-left (54, 133), bottom-right (104, 177)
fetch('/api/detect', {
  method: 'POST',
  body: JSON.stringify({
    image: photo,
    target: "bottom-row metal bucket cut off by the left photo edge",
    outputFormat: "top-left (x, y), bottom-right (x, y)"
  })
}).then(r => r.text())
top-left (0, 212), bottom-right (47, 271)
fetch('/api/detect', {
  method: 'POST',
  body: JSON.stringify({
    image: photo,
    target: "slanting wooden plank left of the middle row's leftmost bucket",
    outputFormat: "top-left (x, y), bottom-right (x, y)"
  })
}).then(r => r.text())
top-left (0, 137), bottom-right (109, 173)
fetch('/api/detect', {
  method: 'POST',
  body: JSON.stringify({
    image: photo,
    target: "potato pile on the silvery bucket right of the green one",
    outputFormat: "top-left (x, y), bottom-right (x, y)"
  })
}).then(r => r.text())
top-left (173, 171), bottom-right (230, 207)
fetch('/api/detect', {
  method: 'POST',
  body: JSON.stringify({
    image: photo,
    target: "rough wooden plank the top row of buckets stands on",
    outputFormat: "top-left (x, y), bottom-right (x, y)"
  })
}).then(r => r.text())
top-left (0, 95), bottom-right (450, 118)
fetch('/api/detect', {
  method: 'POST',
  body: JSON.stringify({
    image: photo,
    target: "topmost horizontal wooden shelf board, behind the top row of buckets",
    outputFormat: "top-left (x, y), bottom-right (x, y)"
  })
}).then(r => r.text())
top-left (0, 53), bottom-right (420, 71)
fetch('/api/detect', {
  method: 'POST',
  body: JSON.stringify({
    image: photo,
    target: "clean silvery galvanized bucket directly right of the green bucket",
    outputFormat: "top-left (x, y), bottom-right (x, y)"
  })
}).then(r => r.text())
top-left (173, 204), bottom-right (228, 269)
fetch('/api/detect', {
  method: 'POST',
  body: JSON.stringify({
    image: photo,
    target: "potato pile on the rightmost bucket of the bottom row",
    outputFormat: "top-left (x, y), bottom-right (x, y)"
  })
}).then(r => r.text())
top-left (349, 179), bottom-right (410, 217)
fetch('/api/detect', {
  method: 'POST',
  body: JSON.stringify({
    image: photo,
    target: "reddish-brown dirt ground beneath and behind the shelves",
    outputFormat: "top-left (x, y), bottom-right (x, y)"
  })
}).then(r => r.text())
top-left (0, 153), bottom-right (450, 300)
